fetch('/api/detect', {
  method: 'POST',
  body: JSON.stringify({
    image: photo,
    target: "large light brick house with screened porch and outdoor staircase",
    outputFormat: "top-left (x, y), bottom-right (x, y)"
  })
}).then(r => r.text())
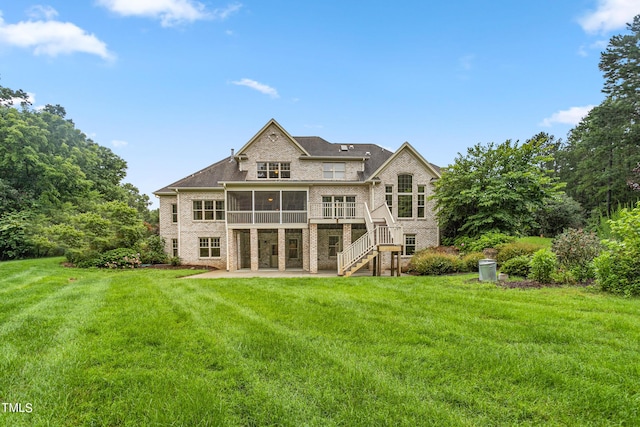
top-left (154, 119), bottom-right (440, 275)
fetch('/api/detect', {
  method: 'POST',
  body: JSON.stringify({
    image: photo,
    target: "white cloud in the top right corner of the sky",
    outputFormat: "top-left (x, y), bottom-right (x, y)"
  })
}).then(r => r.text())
top-left (578, 0), bottom-right (640, 33)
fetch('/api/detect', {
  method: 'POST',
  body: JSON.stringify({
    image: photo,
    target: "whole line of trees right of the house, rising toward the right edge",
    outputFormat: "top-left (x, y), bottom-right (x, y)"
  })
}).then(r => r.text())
top-left (432, 15), bottom-right (640, 243)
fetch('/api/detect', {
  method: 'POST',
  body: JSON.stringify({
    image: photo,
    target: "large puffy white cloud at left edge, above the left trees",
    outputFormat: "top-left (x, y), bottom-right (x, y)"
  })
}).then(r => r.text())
top-left (0, 8), bottom-right (113, 59)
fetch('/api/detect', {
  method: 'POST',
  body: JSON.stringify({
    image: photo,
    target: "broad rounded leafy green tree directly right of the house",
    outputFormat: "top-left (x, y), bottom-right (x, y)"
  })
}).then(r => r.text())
top-left (432, 134), bottom-right (562, 238)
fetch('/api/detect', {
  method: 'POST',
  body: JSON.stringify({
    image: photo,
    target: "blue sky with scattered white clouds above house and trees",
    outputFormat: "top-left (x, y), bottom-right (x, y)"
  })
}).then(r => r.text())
top-left (0, 0), bottom-right (640, 207)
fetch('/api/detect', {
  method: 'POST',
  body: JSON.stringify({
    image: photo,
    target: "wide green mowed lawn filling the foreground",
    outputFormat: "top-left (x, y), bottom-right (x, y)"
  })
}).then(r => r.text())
top-left (0, 259), bottom-right (640, 426)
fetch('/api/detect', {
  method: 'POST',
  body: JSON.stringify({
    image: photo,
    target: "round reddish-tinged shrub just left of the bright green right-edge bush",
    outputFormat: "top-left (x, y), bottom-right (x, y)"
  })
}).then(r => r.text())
top-left (552, 229), bottom-right (602, 282)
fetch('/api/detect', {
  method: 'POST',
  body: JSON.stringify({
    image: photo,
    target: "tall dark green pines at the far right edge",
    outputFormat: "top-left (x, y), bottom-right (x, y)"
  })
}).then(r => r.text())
top-left (559, 15), bottom-right (640, 216)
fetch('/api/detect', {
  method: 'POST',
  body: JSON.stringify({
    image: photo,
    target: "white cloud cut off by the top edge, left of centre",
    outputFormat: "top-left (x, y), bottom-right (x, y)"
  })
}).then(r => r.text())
top-left (98, 0), bottom-right (242, 27)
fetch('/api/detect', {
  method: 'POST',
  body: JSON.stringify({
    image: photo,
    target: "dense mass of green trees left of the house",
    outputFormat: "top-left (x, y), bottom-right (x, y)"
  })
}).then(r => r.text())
top-left (0, 86), bottom-right (160, 261)
